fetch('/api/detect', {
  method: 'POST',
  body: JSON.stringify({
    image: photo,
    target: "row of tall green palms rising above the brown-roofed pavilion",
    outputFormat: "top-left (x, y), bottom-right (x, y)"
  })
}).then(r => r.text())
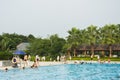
top-left (64, 24), bottom-right (120, 55)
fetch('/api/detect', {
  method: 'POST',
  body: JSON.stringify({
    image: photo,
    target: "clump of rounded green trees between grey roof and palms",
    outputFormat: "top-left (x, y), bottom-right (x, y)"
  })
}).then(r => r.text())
top-left (29, 34), bottom-right (65, 58)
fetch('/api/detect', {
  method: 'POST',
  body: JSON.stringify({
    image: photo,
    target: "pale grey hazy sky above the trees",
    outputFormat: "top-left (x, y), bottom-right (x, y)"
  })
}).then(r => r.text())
top-left (0, 0), bottom-right (120, 38)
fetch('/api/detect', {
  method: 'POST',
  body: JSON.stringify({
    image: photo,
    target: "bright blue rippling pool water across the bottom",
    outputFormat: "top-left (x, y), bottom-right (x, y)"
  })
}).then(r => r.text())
top-left (0, 64), bottom-right (120, 80)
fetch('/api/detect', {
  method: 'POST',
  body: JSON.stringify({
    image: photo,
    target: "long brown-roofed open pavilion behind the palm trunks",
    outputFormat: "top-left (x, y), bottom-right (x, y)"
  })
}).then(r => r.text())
top-left (72, 44), bottom-right (120, 57)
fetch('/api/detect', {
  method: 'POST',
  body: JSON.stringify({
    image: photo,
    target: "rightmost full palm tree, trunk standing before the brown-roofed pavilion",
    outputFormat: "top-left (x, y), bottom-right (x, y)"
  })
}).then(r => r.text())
top-left (101, 24), bottom-right (116, 57)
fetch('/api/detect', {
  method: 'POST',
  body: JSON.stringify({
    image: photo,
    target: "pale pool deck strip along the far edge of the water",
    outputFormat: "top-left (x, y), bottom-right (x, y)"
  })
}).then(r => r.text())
top-left (0, 60), bottom-right (120, 70)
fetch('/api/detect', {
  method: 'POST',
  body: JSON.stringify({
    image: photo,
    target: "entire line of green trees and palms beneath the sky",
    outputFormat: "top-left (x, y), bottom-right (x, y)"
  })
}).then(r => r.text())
top-left (0, 24), bottom-right (120, 59)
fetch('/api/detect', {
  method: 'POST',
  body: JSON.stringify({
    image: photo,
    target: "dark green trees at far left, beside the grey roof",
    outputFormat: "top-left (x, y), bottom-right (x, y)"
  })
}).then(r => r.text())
top-left (0, 33), bottom-right (28, 51)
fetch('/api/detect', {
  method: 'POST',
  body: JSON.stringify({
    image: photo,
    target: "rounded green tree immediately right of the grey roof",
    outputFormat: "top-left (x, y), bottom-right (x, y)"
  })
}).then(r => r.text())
top-left (29, 38), bottom-right (50, 56)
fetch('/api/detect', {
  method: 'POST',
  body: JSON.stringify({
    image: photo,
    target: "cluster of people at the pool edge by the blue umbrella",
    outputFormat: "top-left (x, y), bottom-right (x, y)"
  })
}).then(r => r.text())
top-left (12, 55), bottom-right (40, 68)
